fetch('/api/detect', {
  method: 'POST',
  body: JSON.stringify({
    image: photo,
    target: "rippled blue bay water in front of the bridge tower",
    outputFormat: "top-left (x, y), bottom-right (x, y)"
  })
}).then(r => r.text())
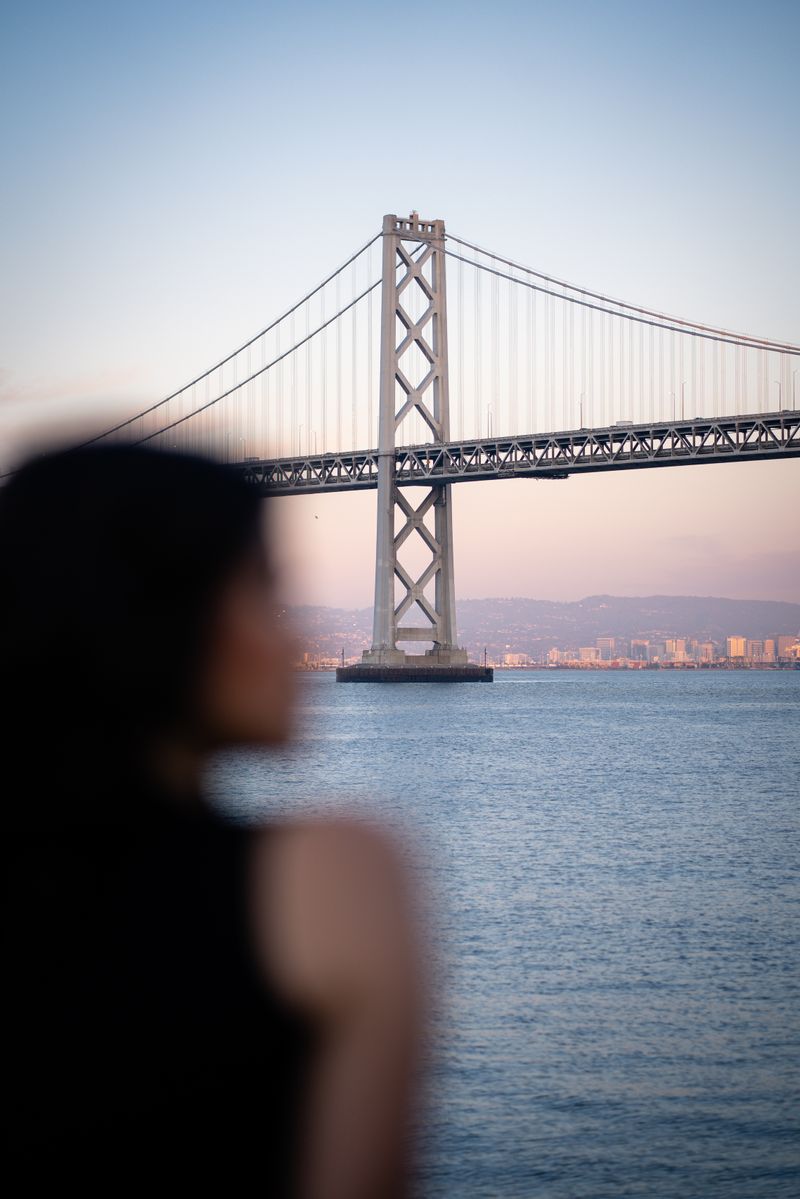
top-left (212, 670), bottom-right (800, 1199)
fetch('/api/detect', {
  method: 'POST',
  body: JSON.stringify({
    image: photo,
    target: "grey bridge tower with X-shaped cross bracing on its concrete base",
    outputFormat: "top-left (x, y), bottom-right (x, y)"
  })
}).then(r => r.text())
top-left (338, 212), bottom-right (491, 681)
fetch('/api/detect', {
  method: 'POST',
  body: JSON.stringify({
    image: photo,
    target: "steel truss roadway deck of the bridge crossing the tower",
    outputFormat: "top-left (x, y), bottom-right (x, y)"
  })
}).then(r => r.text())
top-left (237, 410), bottom-right (800, 495)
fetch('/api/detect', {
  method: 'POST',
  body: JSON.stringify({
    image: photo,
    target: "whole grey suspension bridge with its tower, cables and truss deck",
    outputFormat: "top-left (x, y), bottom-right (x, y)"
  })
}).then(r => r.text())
top-left (87, 212), bottom-right (800, 681)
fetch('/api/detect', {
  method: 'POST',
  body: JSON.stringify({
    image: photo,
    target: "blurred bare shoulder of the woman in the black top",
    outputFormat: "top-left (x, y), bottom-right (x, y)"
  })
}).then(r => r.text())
top-left (251, 818), bottom-right (415, 1012)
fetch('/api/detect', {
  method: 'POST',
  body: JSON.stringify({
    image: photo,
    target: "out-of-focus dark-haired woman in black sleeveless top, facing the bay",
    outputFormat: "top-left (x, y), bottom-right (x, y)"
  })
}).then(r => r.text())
top-left (0, 446), bottom-right (419, 1199)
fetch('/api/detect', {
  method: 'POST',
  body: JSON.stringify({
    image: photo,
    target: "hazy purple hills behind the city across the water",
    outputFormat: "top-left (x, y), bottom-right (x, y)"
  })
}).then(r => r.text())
top-left (289, 596), bottom-right (800, 656)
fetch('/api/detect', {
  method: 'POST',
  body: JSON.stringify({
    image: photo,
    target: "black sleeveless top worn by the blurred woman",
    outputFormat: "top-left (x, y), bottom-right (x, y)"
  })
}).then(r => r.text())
top-left (2, 795), bottom-right (311, 1197)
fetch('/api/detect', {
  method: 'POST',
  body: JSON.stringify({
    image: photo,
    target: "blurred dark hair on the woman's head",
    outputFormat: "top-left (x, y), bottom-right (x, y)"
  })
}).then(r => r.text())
top-left (0, 445), bottom-right (266, 815)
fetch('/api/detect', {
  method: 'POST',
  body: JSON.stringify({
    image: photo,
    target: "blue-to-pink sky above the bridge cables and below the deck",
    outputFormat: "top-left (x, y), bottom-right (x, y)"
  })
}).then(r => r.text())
top-left (0, 0), bottom-right (800, 607)
